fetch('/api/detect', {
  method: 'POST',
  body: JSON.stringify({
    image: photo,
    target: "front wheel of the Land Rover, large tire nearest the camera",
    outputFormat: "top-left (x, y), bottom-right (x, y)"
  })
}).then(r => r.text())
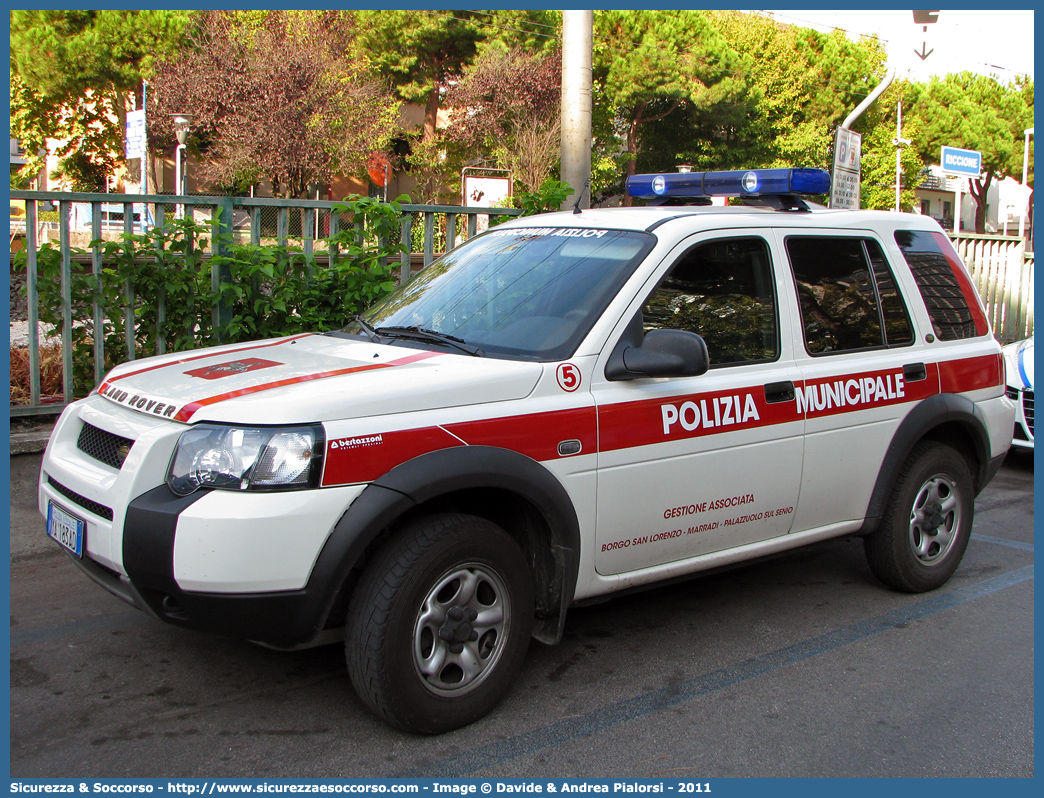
top-left (345, 514), bottom-right (533, 734)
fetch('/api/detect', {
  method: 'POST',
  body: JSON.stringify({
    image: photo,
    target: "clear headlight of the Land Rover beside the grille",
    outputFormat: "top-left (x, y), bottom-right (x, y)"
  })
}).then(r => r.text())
top-left (167, 424), bottom-right (325, 496)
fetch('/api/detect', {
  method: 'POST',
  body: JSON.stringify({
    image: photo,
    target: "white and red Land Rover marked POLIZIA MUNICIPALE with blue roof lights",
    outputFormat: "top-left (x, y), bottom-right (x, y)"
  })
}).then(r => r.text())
top-left (40, 169), bottom-right (1015, 733)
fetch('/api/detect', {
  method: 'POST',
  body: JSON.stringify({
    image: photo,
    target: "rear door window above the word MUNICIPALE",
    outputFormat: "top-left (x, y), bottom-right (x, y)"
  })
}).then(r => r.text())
top-left (786, 236), bottom-right (914, 355)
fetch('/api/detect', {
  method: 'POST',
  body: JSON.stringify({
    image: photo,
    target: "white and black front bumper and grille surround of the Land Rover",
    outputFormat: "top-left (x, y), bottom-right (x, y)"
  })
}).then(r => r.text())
top-left (39, 400), bottom-right (364, 648)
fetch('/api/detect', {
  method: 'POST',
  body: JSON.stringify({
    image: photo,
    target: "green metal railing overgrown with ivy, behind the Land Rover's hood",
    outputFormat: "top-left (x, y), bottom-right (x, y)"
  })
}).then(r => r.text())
top-left (10, 191), bottom-right (522, 416)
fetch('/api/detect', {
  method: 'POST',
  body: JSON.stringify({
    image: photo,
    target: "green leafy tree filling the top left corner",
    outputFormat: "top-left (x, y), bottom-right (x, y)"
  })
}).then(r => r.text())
top-left (10, 10), bottom-right (191, 186)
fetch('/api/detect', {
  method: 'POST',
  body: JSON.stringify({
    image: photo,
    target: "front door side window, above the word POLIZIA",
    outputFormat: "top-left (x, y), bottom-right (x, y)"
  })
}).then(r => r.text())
top-left (642, 237), bottom-right (779, 366)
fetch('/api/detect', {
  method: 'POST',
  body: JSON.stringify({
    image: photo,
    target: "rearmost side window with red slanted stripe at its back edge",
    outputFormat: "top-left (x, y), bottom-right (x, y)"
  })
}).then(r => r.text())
top-left (896, 230), bottom-right (990, 341)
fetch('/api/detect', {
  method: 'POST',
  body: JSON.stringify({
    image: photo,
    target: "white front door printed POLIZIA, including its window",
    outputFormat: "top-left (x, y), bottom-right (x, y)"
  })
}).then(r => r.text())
top-left (592, 231), bottom-right (804, 574)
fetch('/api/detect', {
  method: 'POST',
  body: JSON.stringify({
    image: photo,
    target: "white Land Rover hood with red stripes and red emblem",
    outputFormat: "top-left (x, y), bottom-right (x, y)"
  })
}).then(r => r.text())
top-left (98, 334), bottom-right (543, 424)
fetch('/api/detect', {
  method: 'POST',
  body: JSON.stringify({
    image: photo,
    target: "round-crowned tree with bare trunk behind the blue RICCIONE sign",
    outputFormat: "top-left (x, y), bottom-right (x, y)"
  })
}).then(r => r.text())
top-left (911, 72), bottom-right (1034, 233)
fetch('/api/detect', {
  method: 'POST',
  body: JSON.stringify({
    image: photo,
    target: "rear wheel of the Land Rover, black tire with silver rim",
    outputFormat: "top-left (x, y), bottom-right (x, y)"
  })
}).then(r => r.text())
top-left (863, 441), bottom-right (974, 593)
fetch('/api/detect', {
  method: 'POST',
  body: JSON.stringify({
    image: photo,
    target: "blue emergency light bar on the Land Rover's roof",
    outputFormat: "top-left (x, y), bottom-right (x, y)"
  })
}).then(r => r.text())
top-left (627, 169), bottom-right (830, 200)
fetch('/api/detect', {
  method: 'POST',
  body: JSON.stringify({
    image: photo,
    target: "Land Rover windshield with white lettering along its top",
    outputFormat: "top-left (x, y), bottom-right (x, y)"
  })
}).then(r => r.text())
top-left (343, 228), bottom-right (655, 360)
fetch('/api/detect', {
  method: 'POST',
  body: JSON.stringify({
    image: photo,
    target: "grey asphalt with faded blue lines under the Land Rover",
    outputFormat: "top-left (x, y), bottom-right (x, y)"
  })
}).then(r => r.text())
top-left (10, 454), bottom-right (1034, 781)
